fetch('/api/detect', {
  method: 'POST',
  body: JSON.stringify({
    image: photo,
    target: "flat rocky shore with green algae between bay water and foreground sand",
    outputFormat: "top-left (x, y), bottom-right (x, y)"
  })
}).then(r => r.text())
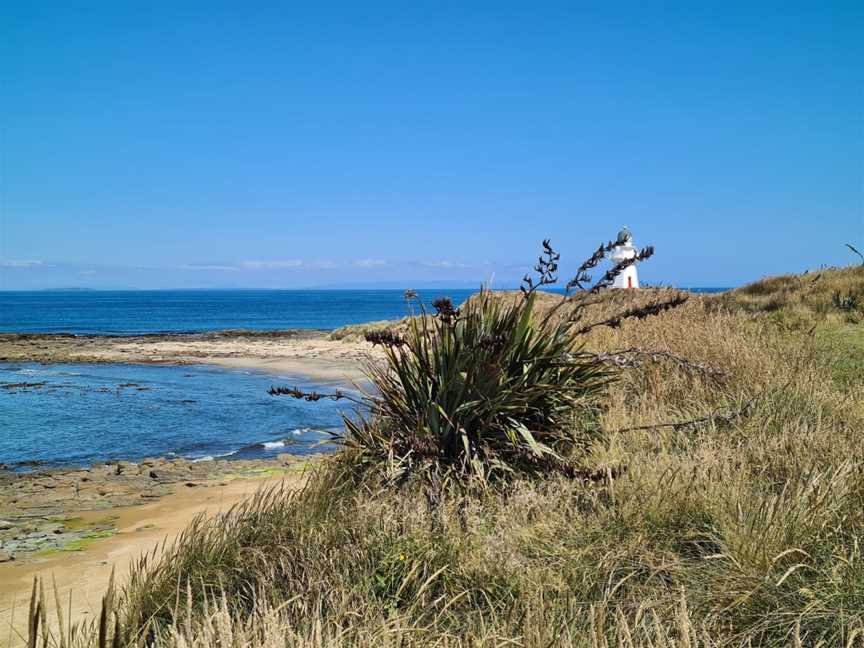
top-left (0, 454), bottom-right (322, 563)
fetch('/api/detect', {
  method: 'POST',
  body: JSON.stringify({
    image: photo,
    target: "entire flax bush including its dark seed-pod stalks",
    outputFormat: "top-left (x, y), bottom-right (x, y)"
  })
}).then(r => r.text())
top-left (270, 240), bottom-right (684, 481)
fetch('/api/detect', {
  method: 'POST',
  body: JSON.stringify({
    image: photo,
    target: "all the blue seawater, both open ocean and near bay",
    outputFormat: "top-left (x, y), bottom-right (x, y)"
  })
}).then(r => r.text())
top-left (0, 289), bottom-right (728, 469)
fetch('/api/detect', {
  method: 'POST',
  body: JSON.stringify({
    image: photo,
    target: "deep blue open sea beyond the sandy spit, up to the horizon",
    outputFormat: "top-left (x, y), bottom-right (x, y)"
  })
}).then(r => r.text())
top-left (0, 287), bottom-right (725, 336)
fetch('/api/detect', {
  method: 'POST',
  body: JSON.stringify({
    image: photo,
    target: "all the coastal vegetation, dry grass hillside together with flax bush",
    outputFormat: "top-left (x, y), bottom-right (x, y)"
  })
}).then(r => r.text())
top-left (15, 251), bottom-right (864, 648)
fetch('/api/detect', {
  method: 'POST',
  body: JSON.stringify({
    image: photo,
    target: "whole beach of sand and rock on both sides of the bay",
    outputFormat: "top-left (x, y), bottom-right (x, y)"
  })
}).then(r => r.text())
top-left (0, 331), bottom-right (374, 646)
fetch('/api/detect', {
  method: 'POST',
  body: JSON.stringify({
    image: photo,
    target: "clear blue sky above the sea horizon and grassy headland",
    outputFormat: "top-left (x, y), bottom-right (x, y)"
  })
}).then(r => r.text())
top-left (0, 0), bottom-right (864, 289)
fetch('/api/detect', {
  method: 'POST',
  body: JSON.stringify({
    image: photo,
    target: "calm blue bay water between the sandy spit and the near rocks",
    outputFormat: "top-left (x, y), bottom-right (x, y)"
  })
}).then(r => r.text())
top-left (0, 363), bottom-right (352, 469)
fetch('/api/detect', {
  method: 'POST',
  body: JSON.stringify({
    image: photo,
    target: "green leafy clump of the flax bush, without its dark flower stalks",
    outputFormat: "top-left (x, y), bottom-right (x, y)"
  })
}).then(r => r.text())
top-left (346, 291), bottom-right (610, 478)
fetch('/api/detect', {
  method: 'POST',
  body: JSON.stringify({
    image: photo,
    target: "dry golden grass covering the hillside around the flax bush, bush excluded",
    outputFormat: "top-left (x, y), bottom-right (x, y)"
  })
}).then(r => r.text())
top-left (18, 268), bottom-right (864, 647)
